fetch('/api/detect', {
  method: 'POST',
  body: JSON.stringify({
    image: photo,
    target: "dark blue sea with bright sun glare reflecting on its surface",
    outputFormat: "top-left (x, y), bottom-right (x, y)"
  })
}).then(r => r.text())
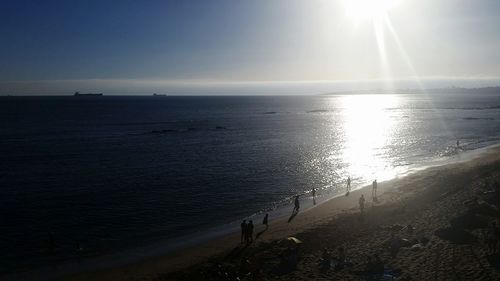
top-left (0, 92), bottom-right (500, 276)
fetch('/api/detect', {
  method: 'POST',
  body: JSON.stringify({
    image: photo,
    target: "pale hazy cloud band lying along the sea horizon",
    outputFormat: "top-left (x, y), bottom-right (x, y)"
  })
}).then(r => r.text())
top-left (0, 76), bottom-right (500, 96)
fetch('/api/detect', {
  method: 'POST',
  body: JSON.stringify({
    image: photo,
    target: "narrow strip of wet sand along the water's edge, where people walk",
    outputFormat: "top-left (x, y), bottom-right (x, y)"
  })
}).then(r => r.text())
top-left (51, 144), bottom-right (500, 280)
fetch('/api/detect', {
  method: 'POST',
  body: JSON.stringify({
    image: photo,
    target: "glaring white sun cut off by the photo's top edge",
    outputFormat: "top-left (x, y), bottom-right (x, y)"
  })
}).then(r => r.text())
top-left (344, 0), bottom-right (396, 21)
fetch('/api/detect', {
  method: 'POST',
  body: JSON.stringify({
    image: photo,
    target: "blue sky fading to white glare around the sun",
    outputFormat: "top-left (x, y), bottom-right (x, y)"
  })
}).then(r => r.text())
top-left (0, 0), bottom-right (500, 95)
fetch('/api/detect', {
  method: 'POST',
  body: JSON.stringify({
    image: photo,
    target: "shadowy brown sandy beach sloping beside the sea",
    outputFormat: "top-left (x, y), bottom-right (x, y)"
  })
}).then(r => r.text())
top-left (61, 146), bottom-right (500, 280)
